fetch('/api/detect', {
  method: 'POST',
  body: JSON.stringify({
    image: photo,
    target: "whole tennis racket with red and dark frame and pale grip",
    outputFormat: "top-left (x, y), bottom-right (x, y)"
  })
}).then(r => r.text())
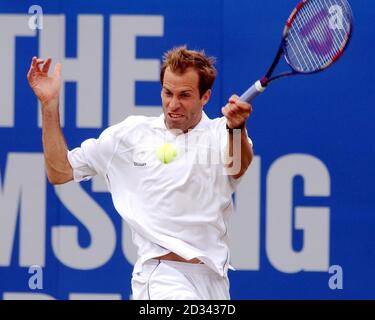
top-left (240, 0), bottom-right (353, 103)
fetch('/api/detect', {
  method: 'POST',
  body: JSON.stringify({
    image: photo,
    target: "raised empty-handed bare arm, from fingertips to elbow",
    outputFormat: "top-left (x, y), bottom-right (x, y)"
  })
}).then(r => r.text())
top-left (27, 57), bottom-right (73, 184)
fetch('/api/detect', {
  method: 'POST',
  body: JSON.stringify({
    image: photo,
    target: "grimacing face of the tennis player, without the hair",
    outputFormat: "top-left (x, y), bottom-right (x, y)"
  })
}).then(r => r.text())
top-left (161, 67), bottom-right (211, 132)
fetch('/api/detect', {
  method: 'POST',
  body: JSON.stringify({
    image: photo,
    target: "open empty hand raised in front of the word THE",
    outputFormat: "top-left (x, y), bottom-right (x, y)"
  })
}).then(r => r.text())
top-left (27, 57), bottom-right (61, 106)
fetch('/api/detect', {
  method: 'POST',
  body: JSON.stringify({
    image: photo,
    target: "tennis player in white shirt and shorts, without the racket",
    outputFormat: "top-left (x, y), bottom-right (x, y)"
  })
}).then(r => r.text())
top-left (28, 47), bottom-right (253, 299)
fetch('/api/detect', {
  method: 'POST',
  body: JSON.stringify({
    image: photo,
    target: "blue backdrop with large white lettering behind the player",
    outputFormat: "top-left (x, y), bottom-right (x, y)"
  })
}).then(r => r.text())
top-left (0, 0), bottom-right (375, 299)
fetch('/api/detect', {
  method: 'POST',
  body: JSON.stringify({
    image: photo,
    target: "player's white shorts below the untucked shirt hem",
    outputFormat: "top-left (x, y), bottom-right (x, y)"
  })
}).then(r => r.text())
top-left (132, 259), bottom-right (230, 300)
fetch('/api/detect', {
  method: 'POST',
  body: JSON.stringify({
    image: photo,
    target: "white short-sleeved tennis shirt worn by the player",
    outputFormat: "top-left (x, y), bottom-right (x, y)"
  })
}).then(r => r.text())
top-left (68, 112), bottom-right (252, 276)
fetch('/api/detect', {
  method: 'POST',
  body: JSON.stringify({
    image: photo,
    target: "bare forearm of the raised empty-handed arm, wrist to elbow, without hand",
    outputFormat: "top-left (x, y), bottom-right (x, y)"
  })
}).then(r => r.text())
top-left (42, 102), bottom-right (73, 184)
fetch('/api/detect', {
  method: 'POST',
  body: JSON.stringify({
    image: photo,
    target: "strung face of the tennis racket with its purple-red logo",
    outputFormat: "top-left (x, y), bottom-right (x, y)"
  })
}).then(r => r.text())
top-left (285, 0), bottom-right (351, 72)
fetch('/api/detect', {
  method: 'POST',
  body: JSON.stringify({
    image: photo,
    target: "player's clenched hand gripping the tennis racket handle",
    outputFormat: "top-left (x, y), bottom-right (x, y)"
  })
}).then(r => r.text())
top-left (221, 95), bottom-right (253, 129)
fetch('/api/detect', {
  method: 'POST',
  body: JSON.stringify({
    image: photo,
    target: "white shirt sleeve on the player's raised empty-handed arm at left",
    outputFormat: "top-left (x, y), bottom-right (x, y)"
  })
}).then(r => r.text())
top-left (68, 117), bottom-right (131, 182)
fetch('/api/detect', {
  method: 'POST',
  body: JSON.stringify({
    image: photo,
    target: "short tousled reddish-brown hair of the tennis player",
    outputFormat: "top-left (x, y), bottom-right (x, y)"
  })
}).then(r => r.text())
top-left (160, 46), bottom-right (216, 97)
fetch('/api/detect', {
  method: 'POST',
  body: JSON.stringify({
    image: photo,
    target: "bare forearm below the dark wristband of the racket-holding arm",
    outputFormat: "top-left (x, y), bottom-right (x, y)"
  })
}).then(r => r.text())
top-left (228, 129), bottom-right (253, 179)
